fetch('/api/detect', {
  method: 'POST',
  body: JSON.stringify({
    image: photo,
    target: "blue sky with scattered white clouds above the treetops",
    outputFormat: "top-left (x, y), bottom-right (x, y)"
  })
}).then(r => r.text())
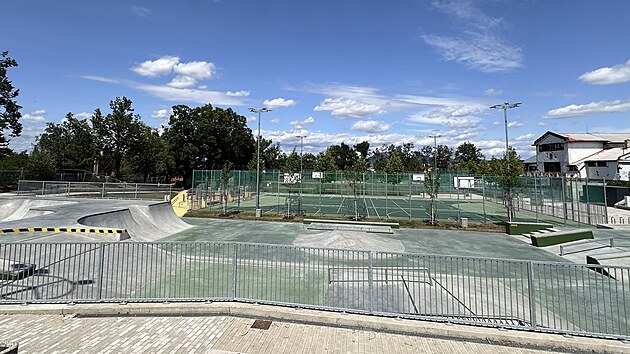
top-left (0, 0), bottom-right (630, 157)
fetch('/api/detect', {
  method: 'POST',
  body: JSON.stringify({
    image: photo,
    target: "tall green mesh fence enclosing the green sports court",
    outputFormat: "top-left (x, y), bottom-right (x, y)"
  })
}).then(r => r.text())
top-left (192, 170), bottom-right (607, 226)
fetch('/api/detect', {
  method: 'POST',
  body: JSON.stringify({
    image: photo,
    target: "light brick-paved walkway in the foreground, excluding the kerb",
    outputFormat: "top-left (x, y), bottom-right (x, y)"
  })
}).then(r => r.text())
top-left (0, 315), bottom-right (568, 354)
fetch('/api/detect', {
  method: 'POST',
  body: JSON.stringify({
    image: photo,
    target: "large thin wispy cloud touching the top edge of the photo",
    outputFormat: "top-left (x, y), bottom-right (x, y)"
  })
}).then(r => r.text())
top-left (421, 1), bottom-right (523, 72)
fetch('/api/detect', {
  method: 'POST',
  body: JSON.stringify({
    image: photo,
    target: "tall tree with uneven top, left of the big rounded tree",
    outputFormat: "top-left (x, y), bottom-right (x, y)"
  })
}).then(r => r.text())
top-left (92, 97), bottom-right (140, 178)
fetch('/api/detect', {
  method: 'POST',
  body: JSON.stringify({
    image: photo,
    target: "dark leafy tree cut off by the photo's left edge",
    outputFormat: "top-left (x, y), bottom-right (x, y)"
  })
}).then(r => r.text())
top-left (0, 52), bottom-right (22, 159)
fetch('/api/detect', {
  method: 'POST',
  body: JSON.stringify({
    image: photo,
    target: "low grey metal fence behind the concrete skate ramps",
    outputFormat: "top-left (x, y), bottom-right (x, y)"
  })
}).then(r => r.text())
top-left (18, 180), bottom-right (179, 200)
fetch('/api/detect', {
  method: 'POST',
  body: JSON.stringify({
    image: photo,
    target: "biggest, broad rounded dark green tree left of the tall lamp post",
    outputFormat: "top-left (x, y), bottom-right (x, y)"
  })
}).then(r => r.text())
top-left (164, 104), bottom-right (262, 185)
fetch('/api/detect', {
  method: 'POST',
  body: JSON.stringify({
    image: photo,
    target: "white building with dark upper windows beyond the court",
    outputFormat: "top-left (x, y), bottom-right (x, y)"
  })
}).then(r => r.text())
top-left (533, 131), bottom-right (630, 181)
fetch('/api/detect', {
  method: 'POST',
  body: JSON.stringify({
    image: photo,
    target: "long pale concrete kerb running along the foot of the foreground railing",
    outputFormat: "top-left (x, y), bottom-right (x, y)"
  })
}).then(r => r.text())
top-left (0, 302), bottom-right (630, 353)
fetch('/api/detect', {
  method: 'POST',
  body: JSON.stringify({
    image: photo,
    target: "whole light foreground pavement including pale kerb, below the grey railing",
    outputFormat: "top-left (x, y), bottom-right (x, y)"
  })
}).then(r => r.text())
top-left (0, 302), bottom-right (630, 354)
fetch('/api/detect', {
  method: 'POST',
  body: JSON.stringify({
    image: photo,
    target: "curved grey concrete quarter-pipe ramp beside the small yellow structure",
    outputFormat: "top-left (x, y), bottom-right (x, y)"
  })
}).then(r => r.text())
top-left (78, 202), bottom-right (193, 241)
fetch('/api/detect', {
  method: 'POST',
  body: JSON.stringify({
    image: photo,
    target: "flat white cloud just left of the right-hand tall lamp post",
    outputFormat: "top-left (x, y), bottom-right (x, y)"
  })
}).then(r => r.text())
top-left (409, 106), bottom-right (481, 128)
